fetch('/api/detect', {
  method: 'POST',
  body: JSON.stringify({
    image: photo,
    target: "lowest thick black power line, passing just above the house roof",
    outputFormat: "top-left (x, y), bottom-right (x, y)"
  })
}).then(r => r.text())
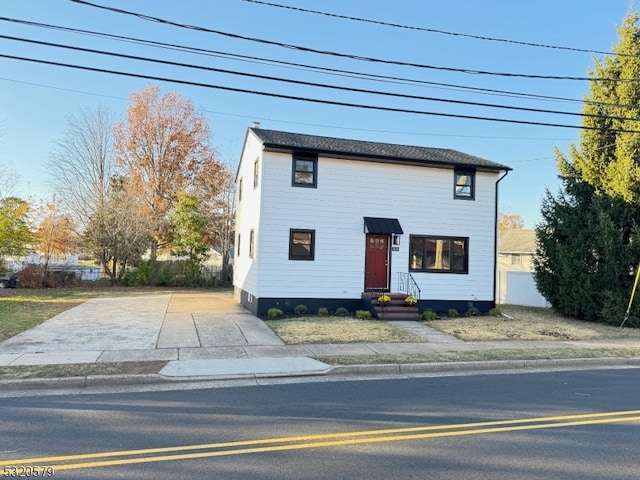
top-left (5, 54), bottom-right (640, 133)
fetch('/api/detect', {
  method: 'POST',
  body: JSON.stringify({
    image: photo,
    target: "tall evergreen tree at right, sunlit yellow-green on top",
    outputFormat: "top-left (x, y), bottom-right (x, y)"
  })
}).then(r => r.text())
top-left (534, 12), bottom-right (640, 324)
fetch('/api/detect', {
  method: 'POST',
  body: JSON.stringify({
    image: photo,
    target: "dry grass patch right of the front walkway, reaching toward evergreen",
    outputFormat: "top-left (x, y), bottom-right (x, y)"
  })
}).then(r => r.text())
top-left (425, 305), bottom-right (640, 341)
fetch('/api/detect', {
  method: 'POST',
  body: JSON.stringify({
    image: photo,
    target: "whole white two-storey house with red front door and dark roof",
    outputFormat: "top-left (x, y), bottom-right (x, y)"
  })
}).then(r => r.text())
top-left (234, 128), bottom-right (511, 315)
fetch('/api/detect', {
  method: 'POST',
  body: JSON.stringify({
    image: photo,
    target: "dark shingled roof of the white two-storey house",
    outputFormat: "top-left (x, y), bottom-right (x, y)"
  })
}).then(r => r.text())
top-left (249, 128), bottom-right (511, 171)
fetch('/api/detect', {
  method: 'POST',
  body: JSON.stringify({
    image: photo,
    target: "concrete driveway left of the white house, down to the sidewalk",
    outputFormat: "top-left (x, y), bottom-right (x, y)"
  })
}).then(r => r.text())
top-left (0, 292), bottom-right (283, 354)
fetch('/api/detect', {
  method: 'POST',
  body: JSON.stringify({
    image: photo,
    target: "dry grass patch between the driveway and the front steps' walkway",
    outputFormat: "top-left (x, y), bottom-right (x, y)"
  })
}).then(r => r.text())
top-left (265, 317), bottom-right (424, 345)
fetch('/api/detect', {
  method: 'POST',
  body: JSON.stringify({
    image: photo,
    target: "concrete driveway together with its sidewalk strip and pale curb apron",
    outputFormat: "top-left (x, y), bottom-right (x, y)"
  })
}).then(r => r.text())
top-left (0, 292), bottom-right (330, 382)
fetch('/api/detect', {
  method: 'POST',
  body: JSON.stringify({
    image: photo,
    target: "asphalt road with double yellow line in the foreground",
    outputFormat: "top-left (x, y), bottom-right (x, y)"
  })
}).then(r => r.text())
top-left (0, 369), bottom-right (640, 480)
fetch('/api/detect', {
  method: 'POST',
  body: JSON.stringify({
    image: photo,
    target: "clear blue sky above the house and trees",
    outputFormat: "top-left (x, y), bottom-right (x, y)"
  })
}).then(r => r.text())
top-left (0, 0), bottom-right (630, 227)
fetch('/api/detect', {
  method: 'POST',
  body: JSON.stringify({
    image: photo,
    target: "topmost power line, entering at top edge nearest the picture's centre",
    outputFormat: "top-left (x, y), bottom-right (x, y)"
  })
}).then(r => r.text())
top-left (243, 0), bottom-right (637, 57)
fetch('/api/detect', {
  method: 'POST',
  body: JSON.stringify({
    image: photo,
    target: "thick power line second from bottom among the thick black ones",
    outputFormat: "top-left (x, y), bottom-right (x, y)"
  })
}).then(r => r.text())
top-left (0, 35), bottom-right (630, 121)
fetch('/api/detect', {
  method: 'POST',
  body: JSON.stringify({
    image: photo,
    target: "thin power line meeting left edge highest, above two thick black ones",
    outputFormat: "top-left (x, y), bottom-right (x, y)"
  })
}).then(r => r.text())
top-left (0, 17), bottom-right (600, 107)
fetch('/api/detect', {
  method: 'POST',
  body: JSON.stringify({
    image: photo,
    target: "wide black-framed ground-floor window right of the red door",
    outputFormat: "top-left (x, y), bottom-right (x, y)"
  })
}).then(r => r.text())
top-left (409, 235), bottom-right (469, 273)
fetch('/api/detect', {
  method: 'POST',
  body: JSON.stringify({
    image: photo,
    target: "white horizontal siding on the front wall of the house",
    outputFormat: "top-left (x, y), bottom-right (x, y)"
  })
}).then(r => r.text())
top-left (250, 151), bottom-right (498, 300)
